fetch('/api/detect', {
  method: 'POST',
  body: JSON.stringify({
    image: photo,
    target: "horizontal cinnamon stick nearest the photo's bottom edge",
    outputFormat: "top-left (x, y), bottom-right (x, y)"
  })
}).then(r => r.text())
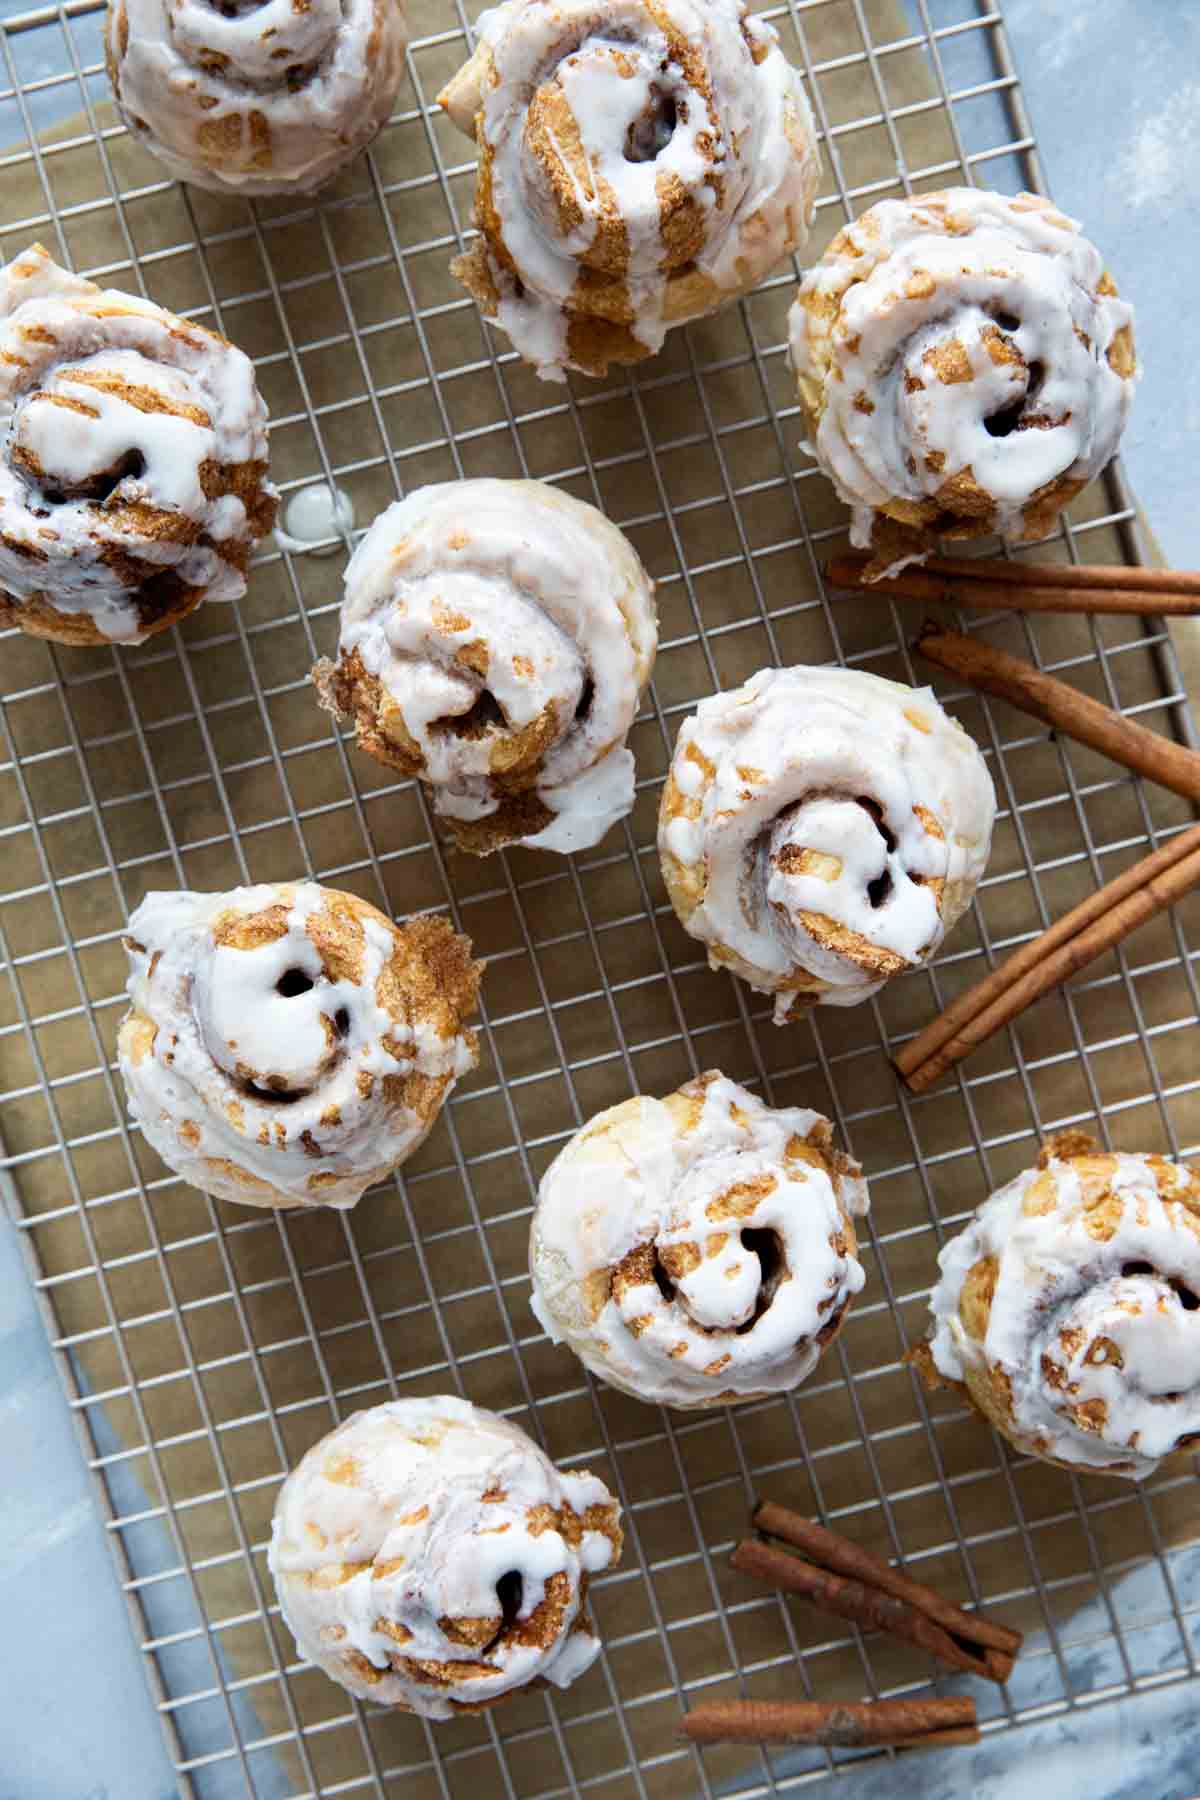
top-left (680, 1699), bottom-right (979, 1750)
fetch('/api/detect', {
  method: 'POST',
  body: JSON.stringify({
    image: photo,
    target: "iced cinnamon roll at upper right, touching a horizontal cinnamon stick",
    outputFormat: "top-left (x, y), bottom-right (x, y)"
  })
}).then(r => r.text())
top-left (792, 187), bottom-right (1137, 574)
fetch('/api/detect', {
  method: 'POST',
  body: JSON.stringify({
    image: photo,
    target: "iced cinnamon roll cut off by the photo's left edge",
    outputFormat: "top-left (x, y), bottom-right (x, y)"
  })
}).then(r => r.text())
top-left (0, 245), bottom-right (275, 644)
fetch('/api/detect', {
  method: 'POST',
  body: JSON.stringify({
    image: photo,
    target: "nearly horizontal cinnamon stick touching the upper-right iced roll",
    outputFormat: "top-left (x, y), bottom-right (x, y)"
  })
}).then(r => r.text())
top-left (826, 554), bottom-right (1200, 617)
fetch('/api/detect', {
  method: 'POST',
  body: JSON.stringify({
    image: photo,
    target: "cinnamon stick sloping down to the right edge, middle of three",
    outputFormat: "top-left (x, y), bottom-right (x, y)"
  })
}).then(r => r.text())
top-left (916, 625), bottom-right (1200, 801)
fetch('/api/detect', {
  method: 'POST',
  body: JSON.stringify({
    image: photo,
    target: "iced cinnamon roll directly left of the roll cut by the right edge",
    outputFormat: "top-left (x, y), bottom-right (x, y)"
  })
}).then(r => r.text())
top-left (529, 1073), bottom-right (867, 1408)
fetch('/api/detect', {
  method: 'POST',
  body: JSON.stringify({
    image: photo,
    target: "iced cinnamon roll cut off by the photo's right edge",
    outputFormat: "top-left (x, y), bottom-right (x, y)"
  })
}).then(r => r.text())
top-left (914, 1132), bottom-right (1200, 1480)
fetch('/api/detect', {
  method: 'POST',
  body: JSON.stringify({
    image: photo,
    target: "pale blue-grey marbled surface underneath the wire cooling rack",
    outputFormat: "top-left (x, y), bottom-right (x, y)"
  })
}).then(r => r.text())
top-left (0, 0), bottom-right (1200, 1800)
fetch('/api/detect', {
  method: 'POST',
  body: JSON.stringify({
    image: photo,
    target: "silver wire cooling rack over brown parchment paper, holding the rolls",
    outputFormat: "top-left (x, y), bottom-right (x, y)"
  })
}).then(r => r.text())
top-left (0, 0), bottom-right (1200, 1800)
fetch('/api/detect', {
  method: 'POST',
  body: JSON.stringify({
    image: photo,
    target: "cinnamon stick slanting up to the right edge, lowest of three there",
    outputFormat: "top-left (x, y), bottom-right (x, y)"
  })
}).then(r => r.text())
top-left (896, 826), bottom-right (1200, 1094)
